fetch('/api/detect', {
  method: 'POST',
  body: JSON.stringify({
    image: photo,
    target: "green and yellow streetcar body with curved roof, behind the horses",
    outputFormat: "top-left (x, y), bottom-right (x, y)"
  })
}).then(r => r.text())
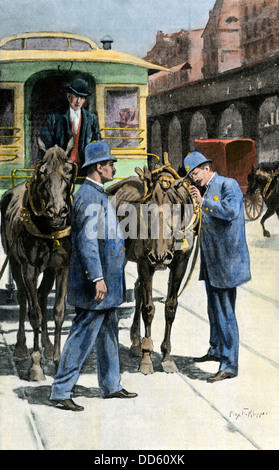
top-left (0, 32), bottom-right (166, 196)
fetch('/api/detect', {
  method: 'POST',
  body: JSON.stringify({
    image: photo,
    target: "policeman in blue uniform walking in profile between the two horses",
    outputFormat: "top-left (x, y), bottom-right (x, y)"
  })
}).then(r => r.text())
top-left (50, 141), bottom-right (137, 411)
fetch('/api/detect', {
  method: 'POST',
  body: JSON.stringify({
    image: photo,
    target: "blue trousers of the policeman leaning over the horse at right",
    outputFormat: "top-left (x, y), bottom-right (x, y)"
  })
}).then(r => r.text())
top-left (205, 280), bottom-right (239, 375)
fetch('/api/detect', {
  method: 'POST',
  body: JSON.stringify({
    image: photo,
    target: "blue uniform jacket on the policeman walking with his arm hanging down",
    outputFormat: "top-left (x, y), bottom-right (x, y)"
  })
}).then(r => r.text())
top-left (67, 179), bottom-right (125, 310)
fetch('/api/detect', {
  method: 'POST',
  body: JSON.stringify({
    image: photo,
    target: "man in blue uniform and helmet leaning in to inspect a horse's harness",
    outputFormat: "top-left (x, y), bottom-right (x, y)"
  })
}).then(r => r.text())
top-left (184, 152), bottom-right (251, 382)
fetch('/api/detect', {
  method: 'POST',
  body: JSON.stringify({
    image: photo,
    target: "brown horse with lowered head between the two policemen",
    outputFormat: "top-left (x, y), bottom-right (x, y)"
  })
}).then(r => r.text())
top-left (107, 158), bottom-right (200, 374)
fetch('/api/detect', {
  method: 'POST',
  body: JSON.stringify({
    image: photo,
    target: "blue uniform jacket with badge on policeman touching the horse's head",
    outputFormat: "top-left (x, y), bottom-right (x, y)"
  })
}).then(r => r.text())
top-left (200, 173), bottom-right (251, 289)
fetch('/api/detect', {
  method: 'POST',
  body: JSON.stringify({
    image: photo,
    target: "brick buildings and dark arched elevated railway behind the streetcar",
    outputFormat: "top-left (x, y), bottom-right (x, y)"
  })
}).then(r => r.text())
top-left (145, 0), bottom-right (279, 169)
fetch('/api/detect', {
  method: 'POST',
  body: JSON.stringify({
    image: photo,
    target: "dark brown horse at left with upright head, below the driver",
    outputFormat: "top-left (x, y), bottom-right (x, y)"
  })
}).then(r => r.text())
top-left (1, 140), bottom-right (76, 381)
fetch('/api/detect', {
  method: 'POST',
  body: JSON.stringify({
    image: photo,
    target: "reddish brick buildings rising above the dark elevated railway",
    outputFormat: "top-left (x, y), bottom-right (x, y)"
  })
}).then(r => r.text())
top-left (145, 0), bottom-right (279, 95)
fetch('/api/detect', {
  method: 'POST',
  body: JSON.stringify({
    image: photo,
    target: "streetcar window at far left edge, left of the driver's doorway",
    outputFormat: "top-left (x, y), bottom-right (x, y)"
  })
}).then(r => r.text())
top-left (0, 89), bottom-right (14, 145)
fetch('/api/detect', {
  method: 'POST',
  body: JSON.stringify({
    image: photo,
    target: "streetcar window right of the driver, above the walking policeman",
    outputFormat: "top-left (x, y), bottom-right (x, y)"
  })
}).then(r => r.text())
top-left (105, 89), bottom-right (140, 148)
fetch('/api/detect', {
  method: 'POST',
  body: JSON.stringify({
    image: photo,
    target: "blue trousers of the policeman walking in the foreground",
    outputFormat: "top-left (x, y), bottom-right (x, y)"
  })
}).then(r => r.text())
top-left (50, 309), bottom-right (122, 400)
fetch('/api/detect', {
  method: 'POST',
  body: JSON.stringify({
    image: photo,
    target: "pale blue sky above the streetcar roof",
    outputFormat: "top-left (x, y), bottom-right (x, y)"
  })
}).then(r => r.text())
top-left (0, 0), bottom-right (215, 57)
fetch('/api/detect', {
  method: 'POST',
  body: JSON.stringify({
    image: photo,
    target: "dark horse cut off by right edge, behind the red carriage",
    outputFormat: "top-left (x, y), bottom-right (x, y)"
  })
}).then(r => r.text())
top-left (247, 162), bottom-right (279, 237)
